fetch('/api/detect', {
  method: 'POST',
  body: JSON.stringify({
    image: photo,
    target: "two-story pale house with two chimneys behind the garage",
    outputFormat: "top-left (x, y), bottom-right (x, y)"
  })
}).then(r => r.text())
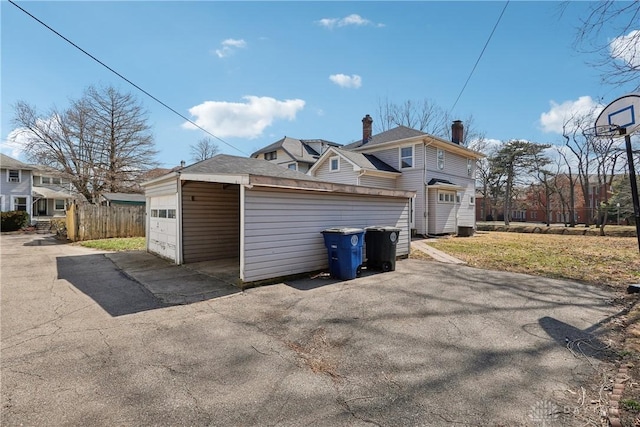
top-left (309, 114), bottom-right (484, 235)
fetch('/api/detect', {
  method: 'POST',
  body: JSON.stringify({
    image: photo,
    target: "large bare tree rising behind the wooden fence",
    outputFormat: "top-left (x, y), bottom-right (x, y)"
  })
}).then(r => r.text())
top-left (13, 86), bottom-right (157, 202)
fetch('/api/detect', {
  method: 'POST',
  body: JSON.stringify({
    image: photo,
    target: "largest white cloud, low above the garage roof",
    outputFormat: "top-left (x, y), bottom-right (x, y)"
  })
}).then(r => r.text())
top-left (182, 96), bottom-right (305, 138)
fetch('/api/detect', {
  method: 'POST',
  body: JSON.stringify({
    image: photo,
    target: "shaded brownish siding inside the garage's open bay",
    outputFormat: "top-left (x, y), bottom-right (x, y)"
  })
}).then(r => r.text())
top-left (182, 182), bottom-right (240, 263)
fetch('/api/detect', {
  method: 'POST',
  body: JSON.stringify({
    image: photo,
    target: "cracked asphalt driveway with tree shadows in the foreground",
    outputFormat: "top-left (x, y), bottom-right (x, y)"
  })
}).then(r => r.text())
top-left (0, 235), bottom-right (618, 426)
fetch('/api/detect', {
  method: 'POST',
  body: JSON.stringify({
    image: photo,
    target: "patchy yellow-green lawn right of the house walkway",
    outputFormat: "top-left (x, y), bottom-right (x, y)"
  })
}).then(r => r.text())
top-left (420, 231), bottom-right (640, 288)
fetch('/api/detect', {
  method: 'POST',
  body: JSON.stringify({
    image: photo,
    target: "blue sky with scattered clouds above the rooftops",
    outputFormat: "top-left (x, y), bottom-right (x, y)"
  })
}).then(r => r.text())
top-left (0, 1), bottom-right (626, 167)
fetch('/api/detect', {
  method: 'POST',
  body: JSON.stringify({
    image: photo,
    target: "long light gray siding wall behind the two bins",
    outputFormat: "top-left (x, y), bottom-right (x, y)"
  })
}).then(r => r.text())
top-left (240, 187), bottom-right (409, 282)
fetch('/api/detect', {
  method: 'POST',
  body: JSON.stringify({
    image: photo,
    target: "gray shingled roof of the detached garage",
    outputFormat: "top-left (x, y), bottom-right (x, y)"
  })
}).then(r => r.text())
top-left (179, 154), bottom-right (319, 181)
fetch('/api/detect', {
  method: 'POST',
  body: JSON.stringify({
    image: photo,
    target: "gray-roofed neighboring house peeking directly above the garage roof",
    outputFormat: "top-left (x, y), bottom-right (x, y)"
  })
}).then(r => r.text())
top-left (251, 136), bottom-right (340, 173)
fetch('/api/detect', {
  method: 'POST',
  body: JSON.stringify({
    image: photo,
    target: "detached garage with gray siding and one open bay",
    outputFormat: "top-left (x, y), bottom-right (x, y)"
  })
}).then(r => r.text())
top-left (143, 155), bottom-right (414, 282)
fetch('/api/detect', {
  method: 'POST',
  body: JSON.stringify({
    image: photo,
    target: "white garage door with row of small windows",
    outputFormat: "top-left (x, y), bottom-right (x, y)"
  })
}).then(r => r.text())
top-left (149, 194), bottom-right (178, 262)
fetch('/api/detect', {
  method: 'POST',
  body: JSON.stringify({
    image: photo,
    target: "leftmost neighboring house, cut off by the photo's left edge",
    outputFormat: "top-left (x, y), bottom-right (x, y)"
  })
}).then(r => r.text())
top-left (0, 153), bottom-right (34, 217)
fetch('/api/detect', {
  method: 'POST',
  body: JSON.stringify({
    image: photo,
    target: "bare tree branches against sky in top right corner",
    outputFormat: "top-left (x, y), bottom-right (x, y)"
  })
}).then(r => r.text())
top-left (562, 0), bottom-right (640, 90)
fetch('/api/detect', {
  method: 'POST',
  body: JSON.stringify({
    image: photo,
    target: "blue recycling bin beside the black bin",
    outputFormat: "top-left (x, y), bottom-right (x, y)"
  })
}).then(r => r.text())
top-left (322, 227), bottom-right (364, 280)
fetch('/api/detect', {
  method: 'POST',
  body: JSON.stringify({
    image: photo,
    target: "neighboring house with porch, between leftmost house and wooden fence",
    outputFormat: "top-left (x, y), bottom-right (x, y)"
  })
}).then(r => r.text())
top-left (31, 165), bottom-right (80, 221)
